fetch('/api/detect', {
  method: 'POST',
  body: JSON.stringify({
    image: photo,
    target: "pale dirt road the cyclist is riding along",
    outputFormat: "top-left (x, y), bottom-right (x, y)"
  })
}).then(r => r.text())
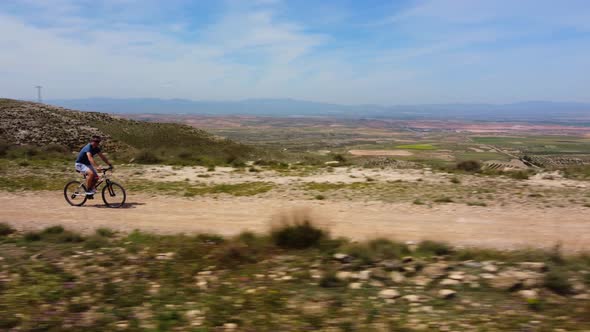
top-left (0, 192), bottom-right (590, 252)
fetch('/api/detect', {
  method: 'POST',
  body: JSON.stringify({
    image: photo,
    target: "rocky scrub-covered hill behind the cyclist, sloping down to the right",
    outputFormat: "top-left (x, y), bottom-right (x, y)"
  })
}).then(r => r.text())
top-left (0, 99), bottom-right (255, 163)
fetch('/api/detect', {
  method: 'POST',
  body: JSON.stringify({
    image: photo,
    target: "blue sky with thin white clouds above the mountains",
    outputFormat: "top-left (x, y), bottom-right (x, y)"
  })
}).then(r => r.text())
top-left (0, 0), bottom-right (590, 104)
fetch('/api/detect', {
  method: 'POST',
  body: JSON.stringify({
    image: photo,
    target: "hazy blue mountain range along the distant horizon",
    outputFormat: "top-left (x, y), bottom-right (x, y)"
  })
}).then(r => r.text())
top-left (48, 98), bottom-right (590, 123)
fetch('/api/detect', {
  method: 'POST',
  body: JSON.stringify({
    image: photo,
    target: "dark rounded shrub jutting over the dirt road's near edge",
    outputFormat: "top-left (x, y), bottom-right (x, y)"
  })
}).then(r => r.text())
top-left (270, 218), bottom-right (328, 249)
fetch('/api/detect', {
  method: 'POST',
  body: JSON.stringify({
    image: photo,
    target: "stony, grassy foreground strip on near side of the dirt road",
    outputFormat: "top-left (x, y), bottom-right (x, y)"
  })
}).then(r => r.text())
top-left (0, 223), bottom-right (590, 331)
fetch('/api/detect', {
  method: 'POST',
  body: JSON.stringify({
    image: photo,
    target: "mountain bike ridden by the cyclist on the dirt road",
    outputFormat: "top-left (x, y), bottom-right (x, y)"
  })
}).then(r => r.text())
top-left (64, 167), bottom-right (127, 208)
